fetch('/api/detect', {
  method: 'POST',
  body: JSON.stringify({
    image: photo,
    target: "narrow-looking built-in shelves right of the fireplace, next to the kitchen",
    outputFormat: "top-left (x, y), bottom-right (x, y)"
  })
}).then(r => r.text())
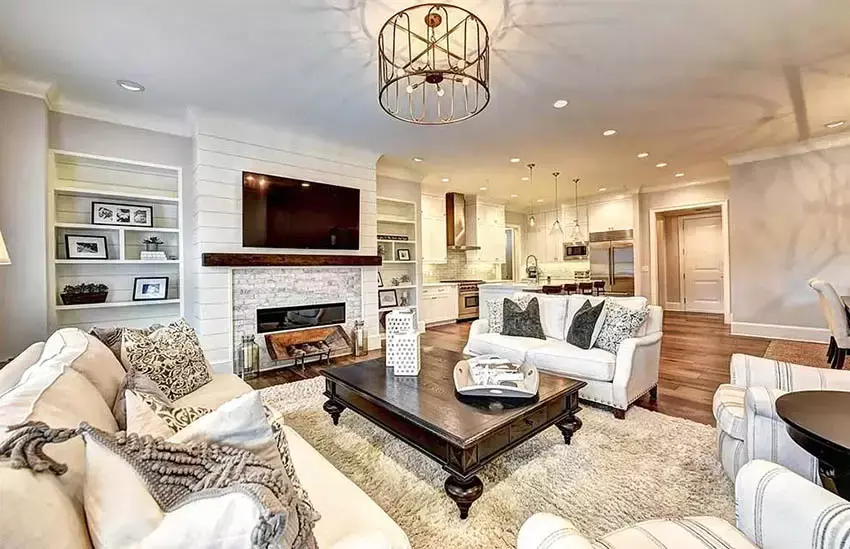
top-left (377, 196), bottom-right (422, 337)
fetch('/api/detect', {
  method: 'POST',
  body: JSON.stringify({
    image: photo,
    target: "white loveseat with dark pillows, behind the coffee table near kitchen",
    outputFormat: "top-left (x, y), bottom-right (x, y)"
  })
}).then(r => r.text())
top-left (463, 294), bottom-right (663, 419)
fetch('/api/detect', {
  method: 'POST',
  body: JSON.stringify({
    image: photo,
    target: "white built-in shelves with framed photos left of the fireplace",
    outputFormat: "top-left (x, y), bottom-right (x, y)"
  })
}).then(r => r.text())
top-left (48, 150), bottom-right (185, 329)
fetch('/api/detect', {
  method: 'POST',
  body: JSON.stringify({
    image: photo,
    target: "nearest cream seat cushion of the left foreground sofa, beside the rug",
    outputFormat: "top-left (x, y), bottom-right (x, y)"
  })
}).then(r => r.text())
top-left (283, 424), bottom-right (410, 549)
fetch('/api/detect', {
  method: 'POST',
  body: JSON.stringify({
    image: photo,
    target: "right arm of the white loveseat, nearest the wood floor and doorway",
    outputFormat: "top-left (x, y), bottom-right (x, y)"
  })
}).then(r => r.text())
top-left (612, 332), bottom-right (662, 410)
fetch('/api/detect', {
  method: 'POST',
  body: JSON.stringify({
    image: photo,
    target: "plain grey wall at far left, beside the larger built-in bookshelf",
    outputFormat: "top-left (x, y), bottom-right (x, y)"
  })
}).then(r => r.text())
top-left (0, 91), bottom-right (47, 362)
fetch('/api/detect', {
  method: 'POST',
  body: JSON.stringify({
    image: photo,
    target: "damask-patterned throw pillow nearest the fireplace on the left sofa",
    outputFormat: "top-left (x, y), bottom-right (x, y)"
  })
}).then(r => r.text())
top-left (121, 319), bottom-right (212, 400)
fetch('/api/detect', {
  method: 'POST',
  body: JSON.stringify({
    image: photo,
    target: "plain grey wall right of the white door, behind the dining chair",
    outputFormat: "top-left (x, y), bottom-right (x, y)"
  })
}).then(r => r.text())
top-left (729, 135), bottom-right (850, 341)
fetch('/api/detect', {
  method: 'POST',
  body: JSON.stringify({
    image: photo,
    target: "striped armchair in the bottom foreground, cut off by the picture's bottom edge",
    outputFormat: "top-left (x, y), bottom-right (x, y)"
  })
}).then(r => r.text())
top-left (517, 460), bottom-right (850, 549)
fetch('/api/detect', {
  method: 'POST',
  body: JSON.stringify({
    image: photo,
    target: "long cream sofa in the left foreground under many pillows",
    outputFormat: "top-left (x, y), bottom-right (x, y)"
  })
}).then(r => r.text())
top-left (0, 328), bottom-right (410, 549)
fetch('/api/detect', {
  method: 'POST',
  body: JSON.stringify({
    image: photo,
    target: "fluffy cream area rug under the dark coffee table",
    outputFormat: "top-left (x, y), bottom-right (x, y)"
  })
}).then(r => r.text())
top-left (262, 378), bottom-right (735, 549)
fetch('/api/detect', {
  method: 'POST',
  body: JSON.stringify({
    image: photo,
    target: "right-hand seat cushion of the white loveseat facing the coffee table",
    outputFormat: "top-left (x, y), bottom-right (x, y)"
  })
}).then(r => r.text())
top-left (526, 340), bottom-right (617, 381)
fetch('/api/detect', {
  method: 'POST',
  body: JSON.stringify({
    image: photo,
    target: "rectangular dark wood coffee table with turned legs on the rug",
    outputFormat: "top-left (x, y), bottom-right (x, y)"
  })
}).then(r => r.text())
top-left (322, 349), bottom-right (585, 519)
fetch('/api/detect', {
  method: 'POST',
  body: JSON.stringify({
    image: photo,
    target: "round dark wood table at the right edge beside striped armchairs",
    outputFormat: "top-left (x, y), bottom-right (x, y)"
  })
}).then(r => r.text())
top-left (776, 391), bottom-right (850, 500)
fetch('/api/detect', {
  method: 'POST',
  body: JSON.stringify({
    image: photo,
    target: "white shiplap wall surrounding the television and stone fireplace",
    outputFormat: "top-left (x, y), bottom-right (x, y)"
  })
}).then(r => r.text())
top-left (192, 113), bottom-right (380, 371)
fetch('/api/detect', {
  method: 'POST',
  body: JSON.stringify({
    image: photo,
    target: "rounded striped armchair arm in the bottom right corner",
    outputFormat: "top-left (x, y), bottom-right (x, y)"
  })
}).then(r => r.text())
top-left (735, 460), bottom-right (850, 549)
